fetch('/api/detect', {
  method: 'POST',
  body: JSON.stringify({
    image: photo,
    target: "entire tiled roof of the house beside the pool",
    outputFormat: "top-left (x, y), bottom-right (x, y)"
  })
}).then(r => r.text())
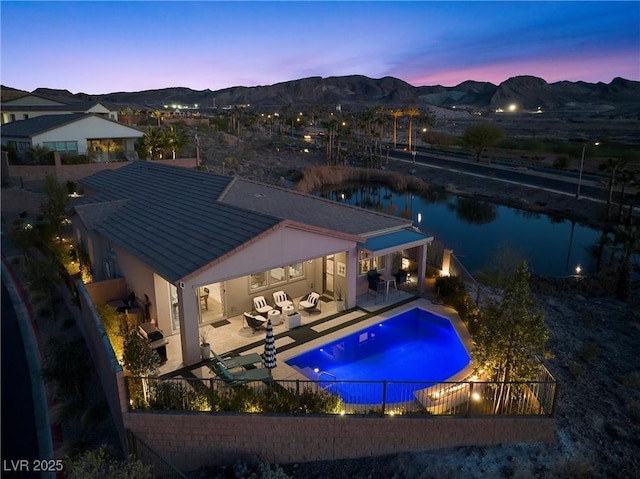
top-left (75, 161), bottom-right (411, 283)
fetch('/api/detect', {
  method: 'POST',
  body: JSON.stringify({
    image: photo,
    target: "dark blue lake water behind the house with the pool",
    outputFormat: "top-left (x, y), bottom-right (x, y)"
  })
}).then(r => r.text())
top-left (320, 186), bottom-right (601, 277)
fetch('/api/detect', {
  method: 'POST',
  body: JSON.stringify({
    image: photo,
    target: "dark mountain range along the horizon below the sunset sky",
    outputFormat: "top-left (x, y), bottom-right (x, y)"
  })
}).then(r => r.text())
top-left (2, 75), bottom-right (640, 120)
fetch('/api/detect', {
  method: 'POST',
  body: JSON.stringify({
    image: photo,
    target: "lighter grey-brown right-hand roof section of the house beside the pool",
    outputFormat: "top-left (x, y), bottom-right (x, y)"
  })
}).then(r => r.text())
top-left (220, 179), bottom-right (411, 236)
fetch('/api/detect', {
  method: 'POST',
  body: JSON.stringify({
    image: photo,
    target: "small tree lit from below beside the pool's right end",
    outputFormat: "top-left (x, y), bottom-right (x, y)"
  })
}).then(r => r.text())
top-left (474, 261), bottom-right (549, 412)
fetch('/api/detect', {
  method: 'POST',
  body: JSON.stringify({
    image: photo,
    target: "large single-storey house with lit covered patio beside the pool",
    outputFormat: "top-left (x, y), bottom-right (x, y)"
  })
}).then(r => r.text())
top-left (73, 161), bottom-right (433, 365)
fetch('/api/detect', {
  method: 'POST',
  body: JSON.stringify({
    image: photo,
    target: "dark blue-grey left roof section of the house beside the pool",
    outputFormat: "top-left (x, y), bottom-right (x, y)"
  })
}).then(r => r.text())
top-left (76, 161), bottom-right (281, 283)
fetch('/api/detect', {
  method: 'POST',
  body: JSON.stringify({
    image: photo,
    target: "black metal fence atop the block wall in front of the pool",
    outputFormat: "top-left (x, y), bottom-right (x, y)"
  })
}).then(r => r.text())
top-left (126, 367), bottom-right (557, 416)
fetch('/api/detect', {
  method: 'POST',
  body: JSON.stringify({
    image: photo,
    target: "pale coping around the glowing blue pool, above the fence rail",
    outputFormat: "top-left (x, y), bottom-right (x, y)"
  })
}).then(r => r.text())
top-left (273, 299), bottom-right (474, 382)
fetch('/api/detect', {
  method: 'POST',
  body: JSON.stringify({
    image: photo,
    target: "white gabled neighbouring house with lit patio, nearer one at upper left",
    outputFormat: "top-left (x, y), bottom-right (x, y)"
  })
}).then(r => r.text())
top-left (1, 113), bottom-right (144, 161)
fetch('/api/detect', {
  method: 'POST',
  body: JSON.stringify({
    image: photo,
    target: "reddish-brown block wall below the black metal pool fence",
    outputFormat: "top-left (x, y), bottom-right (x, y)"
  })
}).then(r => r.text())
top-left (123, 412), bottom-right (555, 470)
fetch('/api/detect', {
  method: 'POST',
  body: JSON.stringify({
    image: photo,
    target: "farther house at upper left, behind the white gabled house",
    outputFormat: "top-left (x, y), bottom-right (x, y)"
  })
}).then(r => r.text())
top-left (1, 93), bottom-right (118, 125)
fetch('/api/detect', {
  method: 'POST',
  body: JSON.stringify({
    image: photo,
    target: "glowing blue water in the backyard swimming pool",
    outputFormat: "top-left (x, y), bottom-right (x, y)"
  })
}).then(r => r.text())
top-left (286, 308), bottom-right (471, 404)
